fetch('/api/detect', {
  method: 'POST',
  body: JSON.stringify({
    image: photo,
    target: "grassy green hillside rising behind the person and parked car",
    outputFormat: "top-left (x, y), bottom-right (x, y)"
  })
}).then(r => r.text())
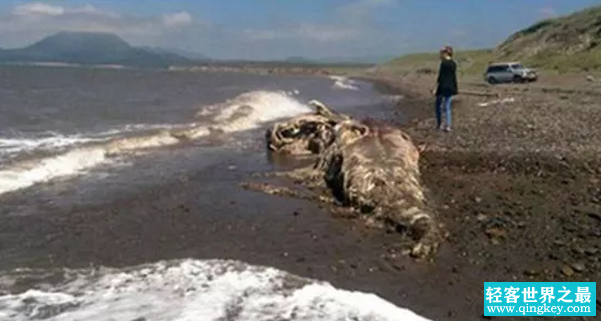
top-left (378, 6), bottom-right (601, 76)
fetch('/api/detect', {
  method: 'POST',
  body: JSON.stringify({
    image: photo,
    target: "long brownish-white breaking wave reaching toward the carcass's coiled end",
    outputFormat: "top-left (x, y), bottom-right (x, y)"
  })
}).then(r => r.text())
top-left (0, 91), bottom-right (310, 194)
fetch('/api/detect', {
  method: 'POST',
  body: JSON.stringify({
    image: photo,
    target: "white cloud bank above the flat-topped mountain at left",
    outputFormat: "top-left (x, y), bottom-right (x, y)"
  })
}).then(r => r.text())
top-left (0, 2), bottom-right (194, 47)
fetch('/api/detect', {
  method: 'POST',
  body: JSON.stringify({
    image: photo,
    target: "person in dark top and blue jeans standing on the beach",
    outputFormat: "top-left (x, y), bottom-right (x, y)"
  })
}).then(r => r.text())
top-left (433, 46), bottom-right (458, 132)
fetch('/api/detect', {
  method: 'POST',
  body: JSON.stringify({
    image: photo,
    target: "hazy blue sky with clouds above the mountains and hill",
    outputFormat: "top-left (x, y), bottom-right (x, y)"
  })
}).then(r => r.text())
top-left (0, 0), bottom-right (601, 60)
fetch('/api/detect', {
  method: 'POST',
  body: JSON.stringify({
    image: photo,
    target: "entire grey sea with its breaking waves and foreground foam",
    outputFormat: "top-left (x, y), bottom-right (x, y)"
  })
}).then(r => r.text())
top-left (0, 66), bottom-right (426, 321)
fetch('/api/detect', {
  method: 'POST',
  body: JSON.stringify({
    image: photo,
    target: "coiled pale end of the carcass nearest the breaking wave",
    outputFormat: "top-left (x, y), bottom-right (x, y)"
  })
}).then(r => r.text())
top-left (265, 100), bottom-right (350, 155)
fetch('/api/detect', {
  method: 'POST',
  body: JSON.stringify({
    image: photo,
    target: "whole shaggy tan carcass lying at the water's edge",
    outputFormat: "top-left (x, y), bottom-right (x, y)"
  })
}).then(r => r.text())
top-left (258, 101), bottom-right (441, 257)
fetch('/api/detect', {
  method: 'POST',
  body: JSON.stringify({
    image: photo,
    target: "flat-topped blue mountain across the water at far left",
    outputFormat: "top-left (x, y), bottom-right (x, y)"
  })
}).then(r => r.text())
top-left (0, 32), bottom-right (193, 68)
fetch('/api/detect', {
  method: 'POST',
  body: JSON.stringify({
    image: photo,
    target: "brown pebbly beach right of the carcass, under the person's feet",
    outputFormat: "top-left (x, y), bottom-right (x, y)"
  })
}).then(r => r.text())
top-left (372, 71), bottom-right (601, 312)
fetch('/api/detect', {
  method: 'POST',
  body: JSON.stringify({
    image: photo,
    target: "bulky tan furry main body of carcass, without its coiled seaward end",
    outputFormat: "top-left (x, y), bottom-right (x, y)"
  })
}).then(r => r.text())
top-left (315, 120), bottom-right (440, 257)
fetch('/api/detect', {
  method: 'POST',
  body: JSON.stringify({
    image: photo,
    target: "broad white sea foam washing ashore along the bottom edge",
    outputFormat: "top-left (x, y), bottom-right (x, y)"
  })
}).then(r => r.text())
top-left (0, 260), bottom-right (427, 321)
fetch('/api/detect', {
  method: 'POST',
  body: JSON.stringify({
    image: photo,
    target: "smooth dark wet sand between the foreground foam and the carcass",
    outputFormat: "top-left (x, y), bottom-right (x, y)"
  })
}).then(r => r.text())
top-left (0, 150), bottom-right (472, 317)
